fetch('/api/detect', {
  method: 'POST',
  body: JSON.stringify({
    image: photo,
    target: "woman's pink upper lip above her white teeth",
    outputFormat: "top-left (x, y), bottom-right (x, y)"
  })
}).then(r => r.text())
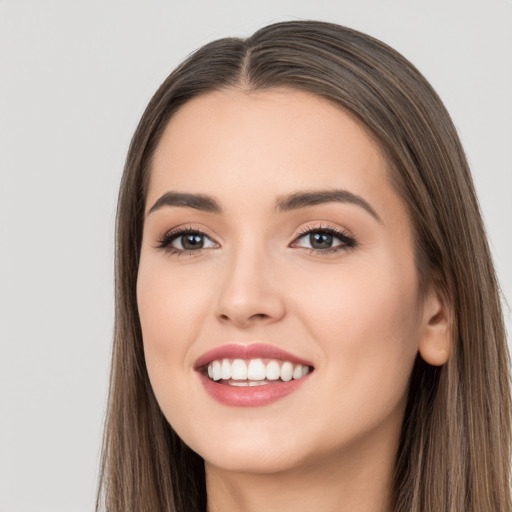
top-left (194, 343), bottom-right (313, 370)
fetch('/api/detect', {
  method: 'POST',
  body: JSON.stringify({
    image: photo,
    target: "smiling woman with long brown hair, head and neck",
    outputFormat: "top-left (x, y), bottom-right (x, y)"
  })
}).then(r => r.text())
top-left (98, 22), bottom-right (511, 512)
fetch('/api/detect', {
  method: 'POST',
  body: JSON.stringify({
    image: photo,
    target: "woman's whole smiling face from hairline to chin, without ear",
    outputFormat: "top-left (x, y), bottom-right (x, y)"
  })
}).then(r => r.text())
top-left (137, 89), bottom-right (423, 473)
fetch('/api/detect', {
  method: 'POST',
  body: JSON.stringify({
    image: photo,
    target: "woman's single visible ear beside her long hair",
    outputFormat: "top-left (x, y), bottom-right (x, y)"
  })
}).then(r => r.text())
top-left (419, 288), bottom-right (453, 366)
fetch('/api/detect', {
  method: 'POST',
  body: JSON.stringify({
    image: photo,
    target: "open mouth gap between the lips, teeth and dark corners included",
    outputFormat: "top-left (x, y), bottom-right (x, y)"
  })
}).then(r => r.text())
top-left (202, 358), bottom-right (313, 387)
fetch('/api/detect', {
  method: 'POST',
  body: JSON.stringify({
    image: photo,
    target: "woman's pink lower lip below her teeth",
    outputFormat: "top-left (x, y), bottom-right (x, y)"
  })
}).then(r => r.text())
top-left (199, 373), bottom-right (308, 407)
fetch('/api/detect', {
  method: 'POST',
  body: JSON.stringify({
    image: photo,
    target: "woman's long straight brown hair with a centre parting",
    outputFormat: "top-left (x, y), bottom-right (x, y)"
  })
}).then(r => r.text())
top-left (97, 21), bottom-right (512, 512)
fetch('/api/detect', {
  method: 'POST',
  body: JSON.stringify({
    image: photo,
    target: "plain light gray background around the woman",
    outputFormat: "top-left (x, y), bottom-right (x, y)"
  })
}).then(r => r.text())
top-left (0, 0), bottom-right (512, 512)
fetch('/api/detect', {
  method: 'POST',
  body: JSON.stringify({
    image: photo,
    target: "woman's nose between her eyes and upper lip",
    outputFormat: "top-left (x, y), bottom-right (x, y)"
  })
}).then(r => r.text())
top-left (216, 243), bottom-right (286, 329)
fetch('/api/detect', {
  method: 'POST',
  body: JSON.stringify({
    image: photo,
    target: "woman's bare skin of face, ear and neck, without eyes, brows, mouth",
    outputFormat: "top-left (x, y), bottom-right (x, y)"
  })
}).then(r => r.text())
top-left (137, 89), bottom-right (448, 512)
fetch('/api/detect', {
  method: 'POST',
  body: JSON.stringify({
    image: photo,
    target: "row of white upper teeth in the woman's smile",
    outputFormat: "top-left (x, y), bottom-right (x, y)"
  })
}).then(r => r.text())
top-left (208, 359), bottom-right (309, 382)
